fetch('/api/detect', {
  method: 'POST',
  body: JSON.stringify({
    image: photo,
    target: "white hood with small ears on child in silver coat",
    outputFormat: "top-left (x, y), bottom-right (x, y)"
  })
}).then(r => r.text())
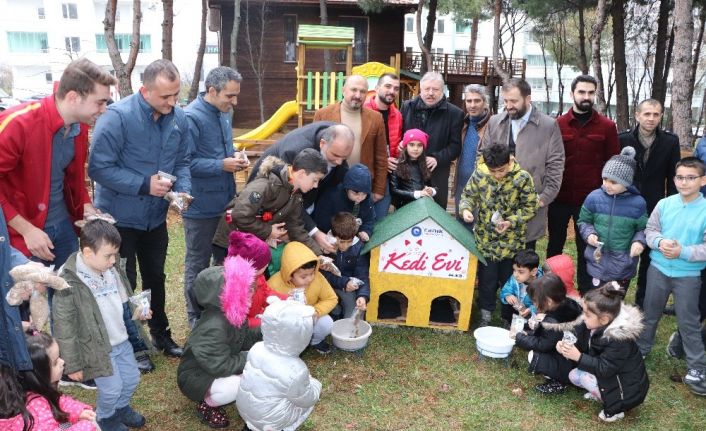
top-left (260, 296), bottom-right (316, 356)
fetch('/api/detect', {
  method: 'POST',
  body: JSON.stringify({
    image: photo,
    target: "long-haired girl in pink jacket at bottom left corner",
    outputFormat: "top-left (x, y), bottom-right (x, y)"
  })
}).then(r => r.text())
top-left (0, 331), bottom-right (96, 431)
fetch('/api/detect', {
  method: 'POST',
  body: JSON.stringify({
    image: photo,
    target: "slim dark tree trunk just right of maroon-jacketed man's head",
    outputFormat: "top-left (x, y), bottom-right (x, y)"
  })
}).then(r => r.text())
top-left (611, 0), bottom-right (630, 130)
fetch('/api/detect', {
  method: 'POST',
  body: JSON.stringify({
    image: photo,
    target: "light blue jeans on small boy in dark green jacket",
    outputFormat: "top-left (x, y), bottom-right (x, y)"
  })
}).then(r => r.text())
top-left (95, 341), bottom-right (140, 420)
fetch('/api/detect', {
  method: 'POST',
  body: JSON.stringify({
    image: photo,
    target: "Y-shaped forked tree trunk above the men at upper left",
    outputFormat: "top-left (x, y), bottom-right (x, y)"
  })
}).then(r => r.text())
top-left (103, 0), bottom-right (142, 97)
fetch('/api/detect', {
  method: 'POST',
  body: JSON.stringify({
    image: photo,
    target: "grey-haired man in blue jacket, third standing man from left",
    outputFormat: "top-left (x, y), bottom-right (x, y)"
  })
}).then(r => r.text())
top-left (182, 66), bottom-right (248, 329)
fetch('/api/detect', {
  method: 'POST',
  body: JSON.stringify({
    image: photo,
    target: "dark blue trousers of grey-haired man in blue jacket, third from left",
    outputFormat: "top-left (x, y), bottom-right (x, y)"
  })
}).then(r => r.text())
top-left (182, 217), bottom-right (220, 329)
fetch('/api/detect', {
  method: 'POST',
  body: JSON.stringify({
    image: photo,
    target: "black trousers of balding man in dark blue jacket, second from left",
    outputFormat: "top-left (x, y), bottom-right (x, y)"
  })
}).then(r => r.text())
top-left (118, 222), bottom-right (170, 337)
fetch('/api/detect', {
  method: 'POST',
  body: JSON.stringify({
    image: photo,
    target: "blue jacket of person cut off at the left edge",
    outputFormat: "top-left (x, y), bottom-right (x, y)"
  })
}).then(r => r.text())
top-left (0, 207), bottom-right (32, 371)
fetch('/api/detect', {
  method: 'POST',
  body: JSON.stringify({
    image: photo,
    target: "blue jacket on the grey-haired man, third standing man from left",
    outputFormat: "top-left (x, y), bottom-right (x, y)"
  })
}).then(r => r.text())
top-left (183, 94), bottom-right (235, 219)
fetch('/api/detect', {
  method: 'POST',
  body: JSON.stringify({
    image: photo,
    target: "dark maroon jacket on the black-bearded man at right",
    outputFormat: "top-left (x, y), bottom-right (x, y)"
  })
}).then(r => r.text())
top-left (554, 107), bottom-right (620, 206)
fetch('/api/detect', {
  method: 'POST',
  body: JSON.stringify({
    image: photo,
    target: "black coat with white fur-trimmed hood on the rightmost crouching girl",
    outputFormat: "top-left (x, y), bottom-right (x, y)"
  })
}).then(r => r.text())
top-left (578, 305), bottom-right (650, 415)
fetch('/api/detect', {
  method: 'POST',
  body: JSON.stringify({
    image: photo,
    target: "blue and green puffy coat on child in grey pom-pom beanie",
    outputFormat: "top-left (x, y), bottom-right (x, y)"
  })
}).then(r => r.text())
top-left (578, 186), bottom-right (647, 281)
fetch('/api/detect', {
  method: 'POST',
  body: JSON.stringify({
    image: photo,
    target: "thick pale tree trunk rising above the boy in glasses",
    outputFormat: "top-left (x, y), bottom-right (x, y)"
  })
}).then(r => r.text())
top-left (672, 0), bottom-right (694, 148)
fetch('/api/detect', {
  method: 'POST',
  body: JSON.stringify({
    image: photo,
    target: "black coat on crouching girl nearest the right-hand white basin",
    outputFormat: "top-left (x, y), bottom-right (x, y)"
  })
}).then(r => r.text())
top-left (515, 298), bottom-right (583, 383)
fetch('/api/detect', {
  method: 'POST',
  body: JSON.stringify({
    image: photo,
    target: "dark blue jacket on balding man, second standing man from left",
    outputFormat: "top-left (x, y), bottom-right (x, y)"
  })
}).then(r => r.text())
top-left (88, 93), bottom-right (191, 230)
